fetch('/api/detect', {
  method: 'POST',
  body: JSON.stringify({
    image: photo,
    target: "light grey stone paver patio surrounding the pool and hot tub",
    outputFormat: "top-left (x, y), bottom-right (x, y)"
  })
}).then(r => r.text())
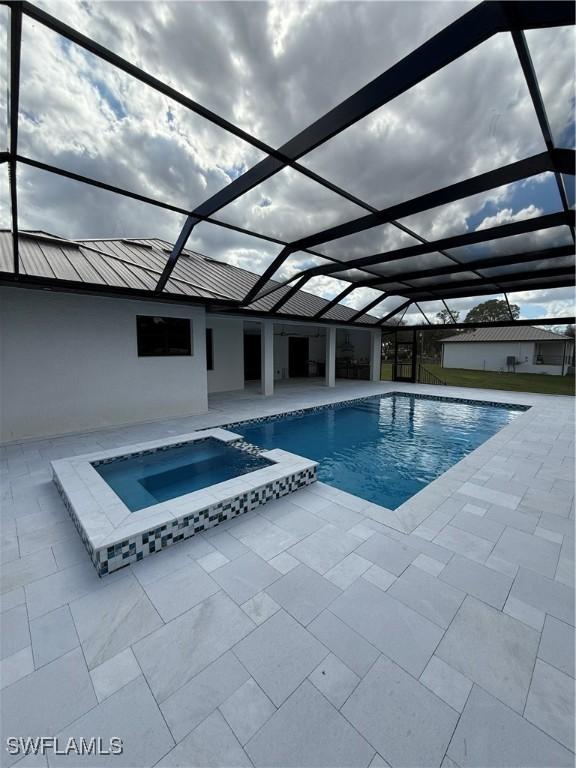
top-left (0, 382), bottom-right (574, 768)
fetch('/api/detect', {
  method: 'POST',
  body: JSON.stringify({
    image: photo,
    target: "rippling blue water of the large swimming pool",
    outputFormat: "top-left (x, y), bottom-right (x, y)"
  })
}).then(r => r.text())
top-left (234, 394), bottom-right (525, 509)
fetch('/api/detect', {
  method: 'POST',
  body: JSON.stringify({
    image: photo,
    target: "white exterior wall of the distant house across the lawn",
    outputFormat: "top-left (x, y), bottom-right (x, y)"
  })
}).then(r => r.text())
top-left (442, 341), bottom-right (563, 375)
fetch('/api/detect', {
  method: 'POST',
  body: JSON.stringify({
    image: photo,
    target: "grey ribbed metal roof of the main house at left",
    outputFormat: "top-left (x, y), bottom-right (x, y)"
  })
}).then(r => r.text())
top-left (0, 230), bottom-right (379, 323)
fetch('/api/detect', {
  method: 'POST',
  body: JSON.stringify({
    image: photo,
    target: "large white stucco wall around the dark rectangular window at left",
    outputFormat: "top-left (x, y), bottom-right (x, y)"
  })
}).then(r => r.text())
top-left (0, 288), bottom-right (207, 442)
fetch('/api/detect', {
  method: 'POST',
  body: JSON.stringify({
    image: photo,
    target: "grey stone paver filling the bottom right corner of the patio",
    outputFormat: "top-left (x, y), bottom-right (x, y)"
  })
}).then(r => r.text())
top-left (448, 685), bottom-right (574, 768)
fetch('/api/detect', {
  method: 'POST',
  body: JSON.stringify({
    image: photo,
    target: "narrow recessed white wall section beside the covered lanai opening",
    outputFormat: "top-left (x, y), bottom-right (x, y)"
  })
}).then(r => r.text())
top-left (206, 315), bottom-right (244, 392)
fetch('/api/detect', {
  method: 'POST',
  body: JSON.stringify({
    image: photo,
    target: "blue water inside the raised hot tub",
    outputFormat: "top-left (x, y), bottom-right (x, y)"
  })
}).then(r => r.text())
top-left (94, 438), bottom-right (272, 512)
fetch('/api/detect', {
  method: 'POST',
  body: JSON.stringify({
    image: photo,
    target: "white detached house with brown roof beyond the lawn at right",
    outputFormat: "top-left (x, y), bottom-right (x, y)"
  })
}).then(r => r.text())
top-left (442, 325), bottom-right (574, 376)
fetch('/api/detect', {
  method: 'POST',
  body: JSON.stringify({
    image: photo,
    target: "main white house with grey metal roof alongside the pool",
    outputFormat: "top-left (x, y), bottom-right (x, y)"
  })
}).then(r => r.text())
top-left (0, 231), bottom-right (388, 442)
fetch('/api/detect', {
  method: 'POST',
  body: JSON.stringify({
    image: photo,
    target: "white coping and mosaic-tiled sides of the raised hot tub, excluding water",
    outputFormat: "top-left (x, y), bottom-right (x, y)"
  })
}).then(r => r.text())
top-left (51, 427), bottom-right (318, 576)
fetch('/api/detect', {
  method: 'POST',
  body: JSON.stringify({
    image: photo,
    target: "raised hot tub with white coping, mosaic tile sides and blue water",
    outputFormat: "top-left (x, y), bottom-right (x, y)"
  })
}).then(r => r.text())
top-left (52, 429), bottom-right (317, 576)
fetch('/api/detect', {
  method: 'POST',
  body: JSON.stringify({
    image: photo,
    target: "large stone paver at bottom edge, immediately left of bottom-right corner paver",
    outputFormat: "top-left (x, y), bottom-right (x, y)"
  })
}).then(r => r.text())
top-left (342, 657), bottom-right (458, 766)
